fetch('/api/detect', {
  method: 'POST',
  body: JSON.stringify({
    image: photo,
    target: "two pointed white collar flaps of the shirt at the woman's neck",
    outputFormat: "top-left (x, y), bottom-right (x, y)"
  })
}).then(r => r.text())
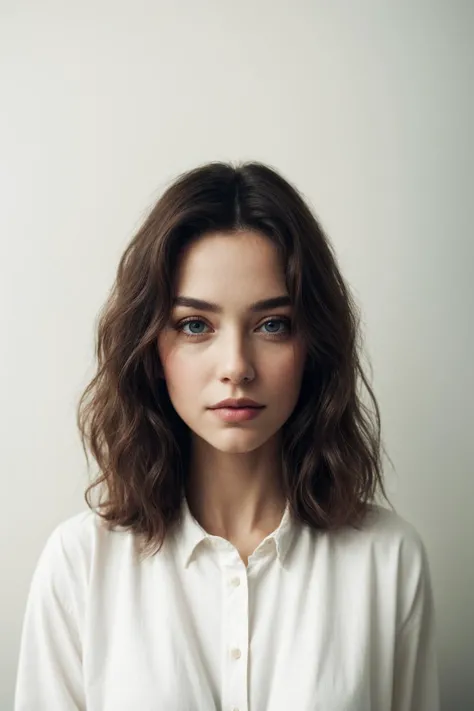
top-left (170, 496), bottom-right (296, 568)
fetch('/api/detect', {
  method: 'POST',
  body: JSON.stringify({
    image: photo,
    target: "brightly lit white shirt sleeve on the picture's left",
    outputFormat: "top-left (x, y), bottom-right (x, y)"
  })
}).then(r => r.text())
top-left (14, 526), bottom-right (86, 711)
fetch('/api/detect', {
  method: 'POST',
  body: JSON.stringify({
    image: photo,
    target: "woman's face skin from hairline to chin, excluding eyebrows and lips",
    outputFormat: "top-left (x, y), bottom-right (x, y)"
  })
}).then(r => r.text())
top-left (158, 232), bottom-right (306, 453)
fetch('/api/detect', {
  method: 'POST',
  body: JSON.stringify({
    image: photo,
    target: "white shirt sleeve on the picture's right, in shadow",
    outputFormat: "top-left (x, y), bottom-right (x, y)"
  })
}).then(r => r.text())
top-left (392, 534), bottom-right (440, 711)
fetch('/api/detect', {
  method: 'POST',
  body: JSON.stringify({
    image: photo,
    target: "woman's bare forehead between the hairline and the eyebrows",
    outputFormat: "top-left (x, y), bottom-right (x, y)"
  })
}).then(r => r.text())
top-left (176, 231), bottom-right (286, 298)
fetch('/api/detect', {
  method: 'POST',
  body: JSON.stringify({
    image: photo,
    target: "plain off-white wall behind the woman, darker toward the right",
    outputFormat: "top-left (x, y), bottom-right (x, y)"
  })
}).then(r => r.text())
top-left (0, 0), bottom-right (474, 711)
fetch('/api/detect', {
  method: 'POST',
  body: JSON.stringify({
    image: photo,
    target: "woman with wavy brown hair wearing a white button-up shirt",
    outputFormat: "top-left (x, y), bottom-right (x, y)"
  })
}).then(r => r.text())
top-left (15, 162), bottom-right (439, 711)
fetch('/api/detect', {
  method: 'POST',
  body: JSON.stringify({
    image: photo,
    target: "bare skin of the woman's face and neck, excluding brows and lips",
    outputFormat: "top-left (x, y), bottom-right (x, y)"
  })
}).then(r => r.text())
top-left (158, 232), bottom-right (306, 561)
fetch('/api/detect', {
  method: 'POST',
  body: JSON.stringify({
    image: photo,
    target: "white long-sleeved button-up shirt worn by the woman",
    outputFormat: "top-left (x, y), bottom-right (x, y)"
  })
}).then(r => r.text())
top-left (15, 499), bottom-right (439, 711)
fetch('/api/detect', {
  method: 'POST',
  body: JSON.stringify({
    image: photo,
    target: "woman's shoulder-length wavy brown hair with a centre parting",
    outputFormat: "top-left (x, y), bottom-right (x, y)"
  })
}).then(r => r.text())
top-left (77, 162), bottom-right (388, 554)
